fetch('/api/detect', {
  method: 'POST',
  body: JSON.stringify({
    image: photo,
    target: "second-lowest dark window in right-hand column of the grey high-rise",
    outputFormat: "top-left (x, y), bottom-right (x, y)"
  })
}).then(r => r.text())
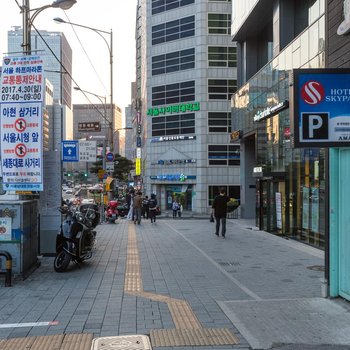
top-left (208, 145), bottom-right (240, 166)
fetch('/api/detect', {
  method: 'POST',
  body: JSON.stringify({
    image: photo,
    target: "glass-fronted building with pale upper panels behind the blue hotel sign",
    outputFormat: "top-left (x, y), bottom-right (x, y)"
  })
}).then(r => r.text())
top-left (231, 0), bottom-right (326, 247)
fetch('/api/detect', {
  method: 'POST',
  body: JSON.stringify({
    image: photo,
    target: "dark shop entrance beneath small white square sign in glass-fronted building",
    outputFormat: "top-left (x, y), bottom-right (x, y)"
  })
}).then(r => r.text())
top-left (256, 179), bottom-right (286, 233)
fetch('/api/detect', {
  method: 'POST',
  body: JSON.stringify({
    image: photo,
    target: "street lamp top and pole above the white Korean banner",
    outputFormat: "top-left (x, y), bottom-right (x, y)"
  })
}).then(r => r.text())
top-left (21, 0), bottom-right (77, 55)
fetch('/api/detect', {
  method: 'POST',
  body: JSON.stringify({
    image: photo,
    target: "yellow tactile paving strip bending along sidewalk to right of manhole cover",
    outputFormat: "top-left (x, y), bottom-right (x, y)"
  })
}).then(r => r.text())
top-left (124, 225), bottom-right (238, 347)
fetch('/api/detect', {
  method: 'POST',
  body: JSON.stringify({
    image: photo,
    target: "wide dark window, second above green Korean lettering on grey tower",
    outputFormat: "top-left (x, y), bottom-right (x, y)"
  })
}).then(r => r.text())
top-left (152, 49), bottom-right (195, 75)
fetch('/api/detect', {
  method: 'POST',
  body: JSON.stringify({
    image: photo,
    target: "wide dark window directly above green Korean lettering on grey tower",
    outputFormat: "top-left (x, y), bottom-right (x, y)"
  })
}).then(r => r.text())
top-left (152, 80), bottom-right (195, 106)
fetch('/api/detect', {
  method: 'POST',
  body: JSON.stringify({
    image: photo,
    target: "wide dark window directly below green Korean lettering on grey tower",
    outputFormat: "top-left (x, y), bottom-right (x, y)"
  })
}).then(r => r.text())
top-left (152, 113), bottom-right (195, 136)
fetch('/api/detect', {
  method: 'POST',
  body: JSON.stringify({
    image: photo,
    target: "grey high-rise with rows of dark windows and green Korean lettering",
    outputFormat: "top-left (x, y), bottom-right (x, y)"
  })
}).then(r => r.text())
top-left (136, 0), bottom-right (240, 213)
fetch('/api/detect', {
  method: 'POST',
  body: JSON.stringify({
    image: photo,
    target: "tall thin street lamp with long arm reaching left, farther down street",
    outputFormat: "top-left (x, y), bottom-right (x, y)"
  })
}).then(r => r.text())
top-left (54, 17), bottom-right (114, 152)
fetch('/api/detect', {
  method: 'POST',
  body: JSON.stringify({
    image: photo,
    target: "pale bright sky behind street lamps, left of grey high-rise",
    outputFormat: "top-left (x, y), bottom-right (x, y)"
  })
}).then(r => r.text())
top-left (0, 0), bottom-right (137, 116)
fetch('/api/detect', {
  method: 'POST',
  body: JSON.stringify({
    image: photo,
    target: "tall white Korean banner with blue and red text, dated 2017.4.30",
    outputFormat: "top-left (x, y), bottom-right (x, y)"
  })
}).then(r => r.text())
top-left (0, 55), bottom-right (45, 191)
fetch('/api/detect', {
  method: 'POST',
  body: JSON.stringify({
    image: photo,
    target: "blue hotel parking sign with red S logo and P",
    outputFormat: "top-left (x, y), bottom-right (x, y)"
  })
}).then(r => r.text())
top-left (291, 69), bottom-right (350, 148)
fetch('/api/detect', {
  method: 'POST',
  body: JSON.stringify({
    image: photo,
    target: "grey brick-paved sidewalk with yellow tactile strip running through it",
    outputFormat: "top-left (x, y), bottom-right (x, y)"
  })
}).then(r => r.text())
top-left (0, 218), bottom-right (350, 350)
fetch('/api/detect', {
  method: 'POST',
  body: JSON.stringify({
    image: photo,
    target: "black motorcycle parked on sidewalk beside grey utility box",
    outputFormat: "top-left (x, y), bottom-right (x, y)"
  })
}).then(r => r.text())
top-left (54, 204), bottom-right (100, 272)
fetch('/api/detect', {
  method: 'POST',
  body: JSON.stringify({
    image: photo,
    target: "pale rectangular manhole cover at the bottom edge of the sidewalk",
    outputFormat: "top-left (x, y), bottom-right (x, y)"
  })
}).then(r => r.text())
top-left (91, 335), bottom-right (151, 350)
